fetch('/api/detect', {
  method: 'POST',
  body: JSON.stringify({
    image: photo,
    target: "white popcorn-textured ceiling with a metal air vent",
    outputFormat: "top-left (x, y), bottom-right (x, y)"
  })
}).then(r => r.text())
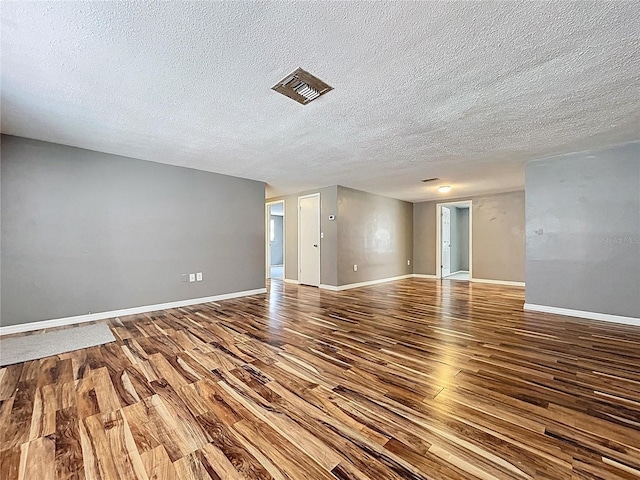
top-left (1, 1), bottom-right (640, 201)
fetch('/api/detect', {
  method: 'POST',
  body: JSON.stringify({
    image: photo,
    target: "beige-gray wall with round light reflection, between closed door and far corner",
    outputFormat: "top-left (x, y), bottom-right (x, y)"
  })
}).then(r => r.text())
top-left (338, 187), bottom-right (413, 285)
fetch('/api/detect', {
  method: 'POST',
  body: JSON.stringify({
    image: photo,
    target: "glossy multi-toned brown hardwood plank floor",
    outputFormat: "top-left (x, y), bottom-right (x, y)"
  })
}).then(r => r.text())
top-left (0, 279), bottom-right (640, 480)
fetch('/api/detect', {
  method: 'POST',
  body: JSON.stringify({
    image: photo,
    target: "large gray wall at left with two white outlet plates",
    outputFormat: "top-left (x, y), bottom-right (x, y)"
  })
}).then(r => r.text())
top-left (1, 136), bottom-right (265, 325)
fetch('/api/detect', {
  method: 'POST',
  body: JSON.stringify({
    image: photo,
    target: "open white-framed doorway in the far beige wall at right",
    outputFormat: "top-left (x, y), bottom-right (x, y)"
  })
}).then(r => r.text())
top-left (436, 200), bottom-right (472, 280)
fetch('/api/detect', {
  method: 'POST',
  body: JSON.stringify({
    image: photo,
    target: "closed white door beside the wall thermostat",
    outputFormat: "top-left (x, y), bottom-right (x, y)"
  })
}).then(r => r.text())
top-left (298, 193), bottom-right (320, 287)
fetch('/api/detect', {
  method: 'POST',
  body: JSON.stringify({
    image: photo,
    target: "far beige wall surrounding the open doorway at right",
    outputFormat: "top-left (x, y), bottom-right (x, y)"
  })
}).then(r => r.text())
top-left (413, 192), bottom-right (525, 282)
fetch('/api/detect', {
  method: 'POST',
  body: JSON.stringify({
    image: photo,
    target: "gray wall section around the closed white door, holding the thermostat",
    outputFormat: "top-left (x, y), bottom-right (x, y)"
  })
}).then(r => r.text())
top-left (267, 185), bottom-right (338, 285)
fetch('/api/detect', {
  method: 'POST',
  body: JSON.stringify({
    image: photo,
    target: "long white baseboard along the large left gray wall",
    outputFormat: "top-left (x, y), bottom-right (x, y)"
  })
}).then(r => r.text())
top-left (0, 288), bottom-right (267, 335)
